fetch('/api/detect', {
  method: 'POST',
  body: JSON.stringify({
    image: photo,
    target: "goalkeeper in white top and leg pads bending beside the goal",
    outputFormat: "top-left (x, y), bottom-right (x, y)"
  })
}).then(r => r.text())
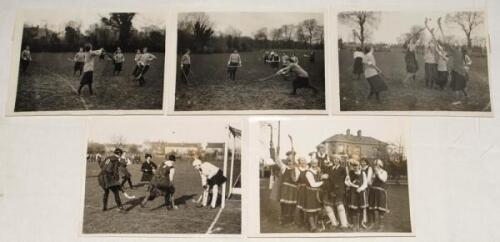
top-left (193, 156), bottom-right (227, 209)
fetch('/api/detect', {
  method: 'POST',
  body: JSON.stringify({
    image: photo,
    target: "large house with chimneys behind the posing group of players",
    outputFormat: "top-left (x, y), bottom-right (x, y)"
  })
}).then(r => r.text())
top-left (321, 129), bottom-right (388, 159)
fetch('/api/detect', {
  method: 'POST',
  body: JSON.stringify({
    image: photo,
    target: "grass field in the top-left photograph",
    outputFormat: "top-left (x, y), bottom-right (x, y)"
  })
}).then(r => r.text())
top-left (15, 53), bottom-right (164, 112)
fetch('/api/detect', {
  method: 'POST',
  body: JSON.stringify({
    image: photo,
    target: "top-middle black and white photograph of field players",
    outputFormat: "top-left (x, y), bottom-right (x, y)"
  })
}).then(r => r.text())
top-left (174, 12), bottom-right (326, 111)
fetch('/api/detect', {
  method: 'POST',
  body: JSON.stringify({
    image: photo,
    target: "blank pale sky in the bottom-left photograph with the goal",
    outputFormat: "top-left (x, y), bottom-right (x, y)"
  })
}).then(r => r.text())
top-left (89, 117), bottom-right (241, 144)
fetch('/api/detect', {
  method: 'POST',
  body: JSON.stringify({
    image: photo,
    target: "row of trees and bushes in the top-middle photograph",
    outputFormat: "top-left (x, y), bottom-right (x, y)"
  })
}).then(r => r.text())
top-left (177, 13), bottom-right (324, 53)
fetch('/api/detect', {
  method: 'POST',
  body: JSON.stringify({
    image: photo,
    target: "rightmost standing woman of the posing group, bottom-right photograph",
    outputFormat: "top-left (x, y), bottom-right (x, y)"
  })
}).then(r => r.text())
top-left (368, 159), bottom-right (389, 231)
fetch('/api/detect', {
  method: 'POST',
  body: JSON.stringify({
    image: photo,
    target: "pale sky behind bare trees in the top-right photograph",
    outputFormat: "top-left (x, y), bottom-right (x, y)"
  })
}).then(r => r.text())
top-left (338, 12), bottom-right (486, 43)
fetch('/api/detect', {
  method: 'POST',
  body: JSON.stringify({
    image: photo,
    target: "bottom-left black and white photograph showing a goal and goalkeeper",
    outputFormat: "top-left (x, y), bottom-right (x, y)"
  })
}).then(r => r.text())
top-left (82, 118), bottom-right (242, 236)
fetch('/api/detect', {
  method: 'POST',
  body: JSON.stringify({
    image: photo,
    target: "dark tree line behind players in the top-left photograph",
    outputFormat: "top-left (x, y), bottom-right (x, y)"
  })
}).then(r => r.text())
top-left (22, 13), bottom-right (165, 52)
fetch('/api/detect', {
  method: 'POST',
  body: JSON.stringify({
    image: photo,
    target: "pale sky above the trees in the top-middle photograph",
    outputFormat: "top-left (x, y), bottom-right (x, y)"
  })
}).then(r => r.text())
top-left (179, 12), bottom-right (324, 37)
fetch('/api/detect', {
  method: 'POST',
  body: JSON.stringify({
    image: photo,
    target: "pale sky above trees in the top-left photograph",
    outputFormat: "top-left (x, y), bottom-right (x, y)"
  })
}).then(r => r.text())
top-left (25, 10), bottom-right (165, 32)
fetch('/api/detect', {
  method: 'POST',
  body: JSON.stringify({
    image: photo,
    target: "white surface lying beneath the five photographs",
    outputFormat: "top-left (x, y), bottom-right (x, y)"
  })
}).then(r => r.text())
top-left (0, 0), bottom-right (500, 242)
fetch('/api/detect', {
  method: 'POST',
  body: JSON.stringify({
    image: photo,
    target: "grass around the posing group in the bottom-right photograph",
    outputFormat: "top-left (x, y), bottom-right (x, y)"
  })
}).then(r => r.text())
top-left (260, 178), bottom-right (411, 233)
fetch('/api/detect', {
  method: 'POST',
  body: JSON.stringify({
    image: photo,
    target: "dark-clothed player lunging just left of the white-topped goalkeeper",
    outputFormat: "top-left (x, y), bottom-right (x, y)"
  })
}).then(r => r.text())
top-left (141, 155), bottom-right (177, 209)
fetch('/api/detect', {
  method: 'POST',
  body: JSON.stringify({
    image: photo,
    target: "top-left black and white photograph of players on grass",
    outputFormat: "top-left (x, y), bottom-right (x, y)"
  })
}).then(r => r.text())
top-left (11, 10), bottom-right (165, 113)
